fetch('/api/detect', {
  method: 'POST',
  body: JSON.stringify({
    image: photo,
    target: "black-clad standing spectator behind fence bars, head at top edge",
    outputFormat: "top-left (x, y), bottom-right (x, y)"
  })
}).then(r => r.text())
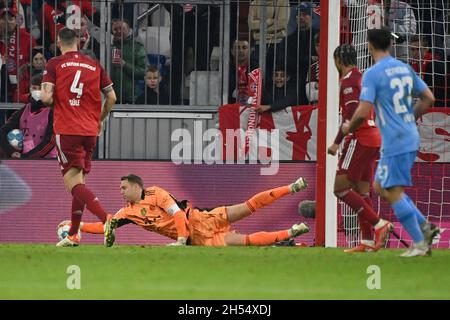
top-left (164, 3), bottom-right (219, 104)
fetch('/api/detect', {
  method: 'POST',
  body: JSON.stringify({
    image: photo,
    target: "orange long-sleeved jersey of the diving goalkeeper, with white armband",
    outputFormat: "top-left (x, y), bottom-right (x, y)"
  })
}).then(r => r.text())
top-left (114, 186), bottom-right (187, 239)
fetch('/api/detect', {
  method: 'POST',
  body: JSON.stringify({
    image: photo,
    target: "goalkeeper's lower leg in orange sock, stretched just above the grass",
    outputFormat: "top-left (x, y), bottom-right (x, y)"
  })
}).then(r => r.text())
top-left (225, 223), bottom-right (309, 246)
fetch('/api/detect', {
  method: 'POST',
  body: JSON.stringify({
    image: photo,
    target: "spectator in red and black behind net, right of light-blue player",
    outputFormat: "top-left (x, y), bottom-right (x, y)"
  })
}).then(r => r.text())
top-left (409, 35), bottom-right (450, 107)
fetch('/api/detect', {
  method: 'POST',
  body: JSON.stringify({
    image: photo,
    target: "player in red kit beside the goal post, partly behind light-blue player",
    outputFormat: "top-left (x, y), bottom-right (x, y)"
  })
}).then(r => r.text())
top-left (328, 44), bottom-right (392, 252)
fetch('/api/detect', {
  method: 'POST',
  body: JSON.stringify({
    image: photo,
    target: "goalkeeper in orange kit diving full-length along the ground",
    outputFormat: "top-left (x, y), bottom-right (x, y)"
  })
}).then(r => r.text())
top-left (81, 174), bottom-right (309, 247)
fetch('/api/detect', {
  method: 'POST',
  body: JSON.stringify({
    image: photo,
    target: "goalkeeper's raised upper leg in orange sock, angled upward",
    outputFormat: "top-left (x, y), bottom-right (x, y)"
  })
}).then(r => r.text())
top-left (227, 178), bottom-right (308, 223)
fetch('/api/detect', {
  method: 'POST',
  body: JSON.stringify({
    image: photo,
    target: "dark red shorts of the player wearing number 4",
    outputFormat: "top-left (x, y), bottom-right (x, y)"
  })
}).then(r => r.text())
top-left (56, 134), bottom-right (97, 175)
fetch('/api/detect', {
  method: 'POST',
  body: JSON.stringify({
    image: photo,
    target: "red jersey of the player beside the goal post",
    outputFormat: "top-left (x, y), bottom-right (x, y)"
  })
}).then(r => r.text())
top-left (339, 68), bottom-right (381, 147)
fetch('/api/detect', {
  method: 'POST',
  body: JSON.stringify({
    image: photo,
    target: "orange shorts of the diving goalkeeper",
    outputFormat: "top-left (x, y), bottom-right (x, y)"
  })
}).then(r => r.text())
top-left (189, 207), bottom-right (231, 246)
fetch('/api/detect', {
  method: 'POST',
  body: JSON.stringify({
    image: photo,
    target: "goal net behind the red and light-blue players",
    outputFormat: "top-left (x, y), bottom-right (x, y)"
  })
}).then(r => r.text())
top-left (337, 0), bottom-right (450, 248)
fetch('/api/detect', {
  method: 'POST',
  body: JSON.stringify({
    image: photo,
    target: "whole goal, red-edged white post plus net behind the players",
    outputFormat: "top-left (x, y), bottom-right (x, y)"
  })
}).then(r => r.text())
top-left (316, 0), bottom-right (450, 249)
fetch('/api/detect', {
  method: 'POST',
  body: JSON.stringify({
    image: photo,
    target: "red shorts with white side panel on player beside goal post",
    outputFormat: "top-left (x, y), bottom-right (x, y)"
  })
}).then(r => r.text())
top-left (336, 139), bottom-right (380, 184)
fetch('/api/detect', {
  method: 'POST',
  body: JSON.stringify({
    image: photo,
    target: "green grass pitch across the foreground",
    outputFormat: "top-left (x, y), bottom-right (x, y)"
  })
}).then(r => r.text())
top-left (0, 244), bottom-right (450, 299)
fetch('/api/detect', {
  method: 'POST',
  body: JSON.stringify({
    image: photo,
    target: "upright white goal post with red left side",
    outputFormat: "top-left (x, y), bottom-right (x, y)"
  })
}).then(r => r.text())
top-left (316, 0), bottom-right (341, 247)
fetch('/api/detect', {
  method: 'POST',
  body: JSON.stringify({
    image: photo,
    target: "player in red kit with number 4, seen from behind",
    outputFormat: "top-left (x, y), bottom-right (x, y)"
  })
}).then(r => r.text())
top-left (41, 28), bottom-right (116, 246)
